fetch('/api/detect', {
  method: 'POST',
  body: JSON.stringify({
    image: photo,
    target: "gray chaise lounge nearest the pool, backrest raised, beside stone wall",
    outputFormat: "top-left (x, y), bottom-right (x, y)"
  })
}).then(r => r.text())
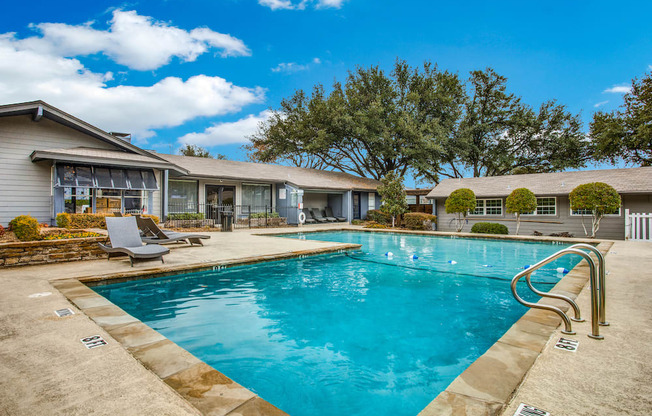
top-left (98, 217), bottom-right (170, 267)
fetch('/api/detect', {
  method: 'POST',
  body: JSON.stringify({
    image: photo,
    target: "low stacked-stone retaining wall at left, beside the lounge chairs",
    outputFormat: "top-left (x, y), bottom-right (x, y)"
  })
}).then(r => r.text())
top-left (0, 237), bottom-right (107, 268)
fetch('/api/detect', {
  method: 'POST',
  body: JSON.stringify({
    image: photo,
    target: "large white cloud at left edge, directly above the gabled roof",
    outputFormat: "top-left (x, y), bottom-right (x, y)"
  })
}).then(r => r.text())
top-left (0, 34), bottom-right (265, 140)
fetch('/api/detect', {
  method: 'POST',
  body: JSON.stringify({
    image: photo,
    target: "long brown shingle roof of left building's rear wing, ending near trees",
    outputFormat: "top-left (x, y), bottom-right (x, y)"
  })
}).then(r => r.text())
top-left (157, 153), bottom-right (380, 191)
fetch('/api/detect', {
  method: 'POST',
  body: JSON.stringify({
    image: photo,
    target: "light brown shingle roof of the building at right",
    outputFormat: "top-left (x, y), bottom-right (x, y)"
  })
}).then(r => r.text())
top-left (428, 167), bottom-right (652, 198)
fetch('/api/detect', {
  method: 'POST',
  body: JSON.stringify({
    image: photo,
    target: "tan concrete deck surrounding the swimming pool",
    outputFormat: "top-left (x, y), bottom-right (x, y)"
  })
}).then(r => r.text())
top-left (0, 224), bottom-right (652, 416)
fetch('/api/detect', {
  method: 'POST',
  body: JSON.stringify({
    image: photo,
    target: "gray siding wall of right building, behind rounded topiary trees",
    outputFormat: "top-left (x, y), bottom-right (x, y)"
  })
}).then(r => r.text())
top-left (437, 195), bottom-right (652, 240)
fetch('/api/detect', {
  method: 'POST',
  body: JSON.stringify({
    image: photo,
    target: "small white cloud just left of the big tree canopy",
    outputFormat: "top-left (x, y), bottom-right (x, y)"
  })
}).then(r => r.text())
top-left (179, 110), bottom-right (272, 146)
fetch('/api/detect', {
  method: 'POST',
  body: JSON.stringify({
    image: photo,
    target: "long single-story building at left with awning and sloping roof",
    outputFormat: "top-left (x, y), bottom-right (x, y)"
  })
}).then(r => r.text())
top-left (0, 101), bottom-right (380, 226)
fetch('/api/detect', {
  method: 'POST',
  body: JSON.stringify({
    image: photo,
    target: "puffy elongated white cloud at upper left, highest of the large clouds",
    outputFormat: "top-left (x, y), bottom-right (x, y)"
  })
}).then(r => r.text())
top-left (15, 10), bottom-right (251, 70)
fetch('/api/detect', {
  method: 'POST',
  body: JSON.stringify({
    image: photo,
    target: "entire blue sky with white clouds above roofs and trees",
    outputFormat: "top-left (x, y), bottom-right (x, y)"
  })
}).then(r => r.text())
top-left (0, 0), bottom-right (652, 173)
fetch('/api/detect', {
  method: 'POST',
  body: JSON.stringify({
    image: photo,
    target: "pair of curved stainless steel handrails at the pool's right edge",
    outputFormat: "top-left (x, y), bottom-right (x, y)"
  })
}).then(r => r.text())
top-left (511, 248), bottom-right (604, 339)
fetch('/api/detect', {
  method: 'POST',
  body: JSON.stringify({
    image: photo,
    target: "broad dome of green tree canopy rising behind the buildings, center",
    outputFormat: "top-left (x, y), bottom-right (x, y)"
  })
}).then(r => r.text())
top-left (245, 60), bottom-right (589, 183)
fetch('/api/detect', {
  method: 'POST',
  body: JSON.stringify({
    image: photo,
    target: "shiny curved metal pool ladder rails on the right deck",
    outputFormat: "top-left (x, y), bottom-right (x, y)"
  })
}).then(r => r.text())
top-left (511, 244), bottom-right (609, 339)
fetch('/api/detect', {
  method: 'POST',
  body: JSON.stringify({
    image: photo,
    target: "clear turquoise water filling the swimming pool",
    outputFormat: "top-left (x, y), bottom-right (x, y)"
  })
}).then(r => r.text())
top-left (94, 232), bottom-right (580, 416)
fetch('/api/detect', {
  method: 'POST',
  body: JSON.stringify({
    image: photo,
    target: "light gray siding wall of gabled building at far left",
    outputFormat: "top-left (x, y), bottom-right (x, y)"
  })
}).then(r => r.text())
top-left (0, 116), bottom-right (118, 226)
